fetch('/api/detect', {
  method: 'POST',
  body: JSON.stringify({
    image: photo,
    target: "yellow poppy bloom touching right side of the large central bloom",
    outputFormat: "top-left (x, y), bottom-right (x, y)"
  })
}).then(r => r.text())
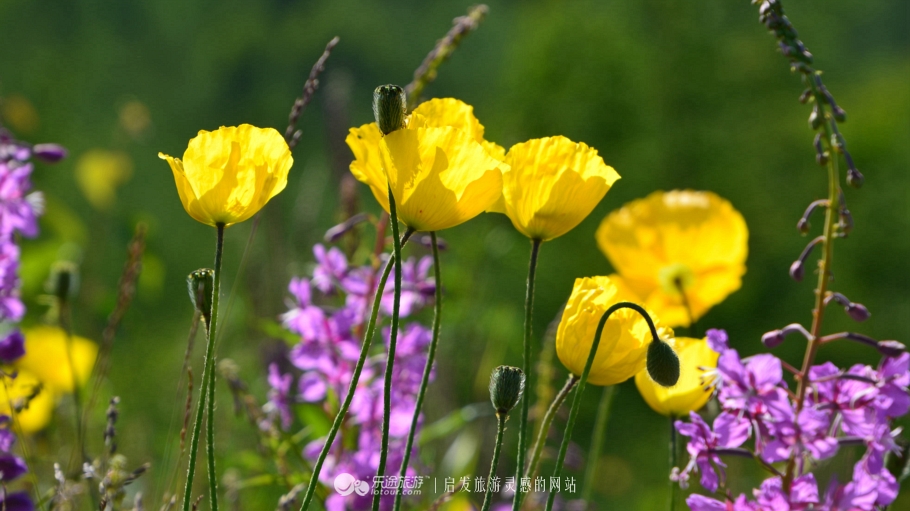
top-left (490, 136), bottom-right (619, 241)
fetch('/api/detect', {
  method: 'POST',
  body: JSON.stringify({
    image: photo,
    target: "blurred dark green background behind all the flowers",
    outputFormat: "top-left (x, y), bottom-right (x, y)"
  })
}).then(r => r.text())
top-left (0, 0), bottom-right (910, 510)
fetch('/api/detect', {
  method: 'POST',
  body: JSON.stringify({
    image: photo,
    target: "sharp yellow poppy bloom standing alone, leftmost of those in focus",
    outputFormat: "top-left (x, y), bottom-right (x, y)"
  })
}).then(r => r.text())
top-left (158, 124), bottom-right (294, 226)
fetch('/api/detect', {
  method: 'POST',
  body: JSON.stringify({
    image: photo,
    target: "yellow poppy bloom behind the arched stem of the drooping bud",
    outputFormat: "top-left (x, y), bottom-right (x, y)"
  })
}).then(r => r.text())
top-left (556, 277), bottom-right (673, 385)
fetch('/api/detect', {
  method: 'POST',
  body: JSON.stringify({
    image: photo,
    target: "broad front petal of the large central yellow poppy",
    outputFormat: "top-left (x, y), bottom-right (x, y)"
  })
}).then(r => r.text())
top-left (380, 127), bottom-right (503, 231)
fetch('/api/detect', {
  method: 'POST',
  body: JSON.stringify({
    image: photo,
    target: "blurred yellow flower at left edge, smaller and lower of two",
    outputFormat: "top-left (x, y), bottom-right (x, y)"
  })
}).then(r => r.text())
top-left (0, 370), bottom-right (56, 434)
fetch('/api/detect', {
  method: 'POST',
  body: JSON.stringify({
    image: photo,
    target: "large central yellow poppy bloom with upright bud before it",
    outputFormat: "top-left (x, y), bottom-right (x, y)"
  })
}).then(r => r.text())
top-left (345, 98), bottom-right (506, 231)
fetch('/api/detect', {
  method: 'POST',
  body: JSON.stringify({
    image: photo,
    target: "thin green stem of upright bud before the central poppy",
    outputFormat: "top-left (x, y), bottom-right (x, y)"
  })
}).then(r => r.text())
top-left (373, 185), bottom-right (410, 511)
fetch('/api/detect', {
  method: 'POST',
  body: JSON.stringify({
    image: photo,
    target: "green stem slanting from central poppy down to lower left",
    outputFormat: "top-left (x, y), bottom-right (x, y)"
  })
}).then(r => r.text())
top-left (300, 229), bottom-right (414, 511)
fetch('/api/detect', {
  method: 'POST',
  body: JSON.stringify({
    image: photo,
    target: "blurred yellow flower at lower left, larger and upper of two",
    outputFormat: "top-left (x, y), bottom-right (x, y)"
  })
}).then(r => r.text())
top-left (15, 326), bottom-right (98, 394)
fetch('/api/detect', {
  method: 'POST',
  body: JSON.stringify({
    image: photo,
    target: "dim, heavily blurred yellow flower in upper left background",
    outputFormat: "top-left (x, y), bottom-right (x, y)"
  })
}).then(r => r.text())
top-left (76, 149), bottom-right (133, 211)
